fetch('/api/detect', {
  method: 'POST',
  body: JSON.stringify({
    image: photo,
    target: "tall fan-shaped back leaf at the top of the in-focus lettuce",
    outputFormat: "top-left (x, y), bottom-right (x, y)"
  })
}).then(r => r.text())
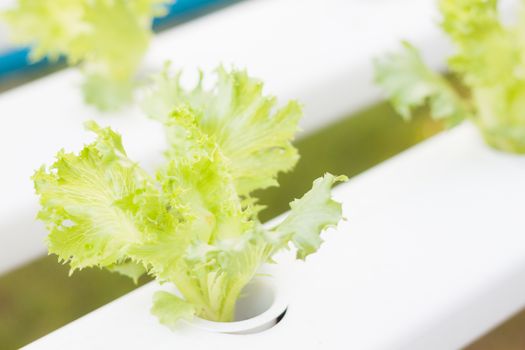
top-left (143, 67), bottom-right (302, 195)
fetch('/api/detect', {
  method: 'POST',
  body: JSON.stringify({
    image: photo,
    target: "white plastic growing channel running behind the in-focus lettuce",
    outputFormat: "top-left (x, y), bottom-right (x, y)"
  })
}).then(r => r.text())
top-left (0, 0), bottom-right (446, 273)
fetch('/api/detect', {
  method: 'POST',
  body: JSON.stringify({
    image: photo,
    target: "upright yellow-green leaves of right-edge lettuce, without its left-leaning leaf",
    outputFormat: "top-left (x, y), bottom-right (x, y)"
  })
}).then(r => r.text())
top-left (440, 0), bottom-right (525, 153)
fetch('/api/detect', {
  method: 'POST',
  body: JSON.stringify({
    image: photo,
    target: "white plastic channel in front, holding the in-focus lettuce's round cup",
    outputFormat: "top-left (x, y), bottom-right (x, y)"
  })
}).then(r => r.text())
top-left (28, 124), bottom-right (525, 350)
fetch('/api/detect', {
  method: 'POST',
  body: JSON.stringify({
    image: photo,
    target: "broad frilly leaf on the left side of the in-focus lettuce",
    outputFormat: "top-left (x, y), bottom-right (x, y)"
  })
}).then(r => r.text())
top-left (33, 123), bottom-right (155, 271)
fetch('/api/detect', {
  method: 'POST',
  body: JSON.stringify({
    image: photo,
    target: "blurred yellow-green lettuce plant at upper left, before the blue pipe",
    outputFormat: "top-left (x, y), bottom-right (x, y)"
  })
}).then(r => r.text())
top-left (1, 0), bottom-right (172, 110)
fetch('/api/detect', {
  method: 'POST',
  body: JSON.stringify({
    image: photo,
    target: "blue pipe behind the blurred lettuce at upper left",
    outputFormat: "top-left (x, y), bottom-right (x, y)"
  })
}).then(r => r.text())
top-left (0, 0), bottom-right (233, 80)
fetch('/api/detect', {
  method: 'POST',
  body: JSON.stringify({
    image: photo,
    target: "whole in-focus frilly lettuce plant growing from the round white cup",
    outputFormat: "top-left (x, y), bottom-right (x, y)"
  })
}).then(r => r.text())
top-left (33, 68), bottom-right (345, 327)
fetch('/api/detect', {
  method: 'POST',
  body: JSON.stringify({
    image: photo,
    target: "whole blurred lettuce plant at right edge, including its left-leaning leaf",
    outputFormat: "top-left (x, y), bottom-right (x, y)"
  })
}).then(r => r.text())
top-left (375, 0), bottom-right (525, 153)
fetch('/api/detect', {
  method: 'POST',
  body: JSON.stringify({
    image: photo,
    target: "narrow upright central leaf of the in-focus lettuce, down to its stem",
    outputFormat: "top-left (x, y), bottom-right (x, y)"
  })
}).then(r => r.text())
top-left (129, 108), bottom-right (256, 320)
